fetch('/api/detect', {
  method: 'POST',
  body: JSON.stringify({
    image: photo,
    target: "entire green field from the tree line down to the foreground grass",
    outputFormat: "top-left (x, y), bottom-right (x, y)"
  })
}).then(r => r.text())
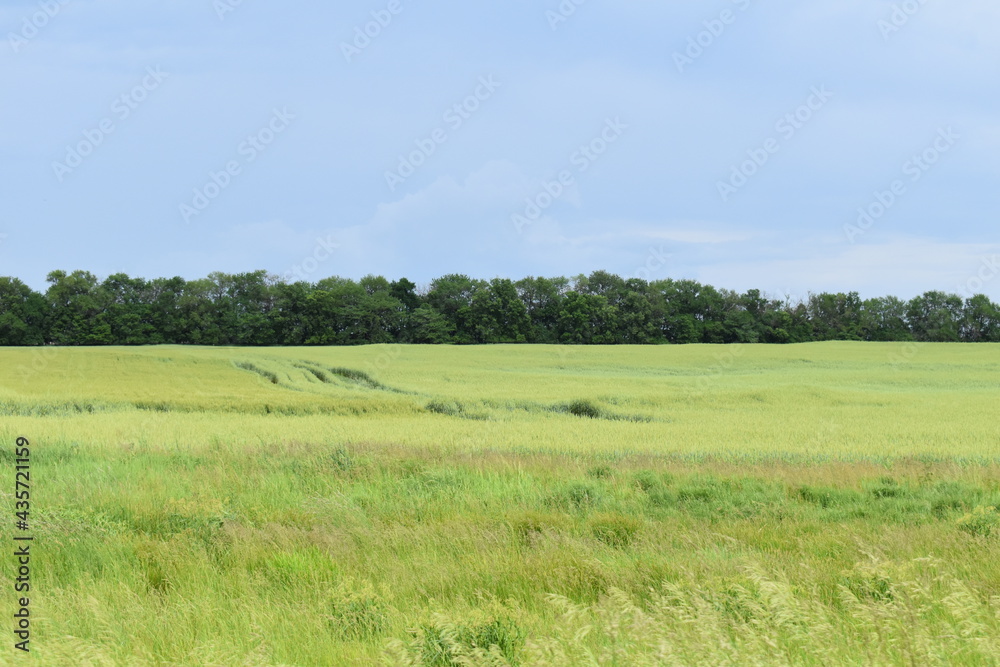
top-left (0, 343), bottom-right (1000, 665)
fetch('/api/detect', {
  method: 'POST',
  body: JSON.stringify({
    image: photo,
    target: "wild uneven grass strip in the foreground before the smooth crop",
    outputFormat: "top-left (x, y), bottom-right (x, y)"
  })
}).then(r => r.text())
top-left (2, 443), bottom-right (1000, 665)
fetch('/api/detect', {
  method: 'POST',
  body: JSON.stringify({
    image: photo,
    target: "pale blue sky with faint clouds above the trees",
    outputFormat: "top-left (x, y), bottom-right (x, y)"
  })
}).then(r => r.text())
top-left (0, 0), bottom-right (1000, 301)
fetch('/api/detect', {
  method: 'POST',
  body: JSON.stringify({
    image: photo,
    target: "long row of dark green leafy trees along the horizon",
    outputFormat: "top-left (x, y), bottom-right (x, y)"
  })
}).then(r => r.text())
top-left (0, 271), bottom-right (1000, 345)
